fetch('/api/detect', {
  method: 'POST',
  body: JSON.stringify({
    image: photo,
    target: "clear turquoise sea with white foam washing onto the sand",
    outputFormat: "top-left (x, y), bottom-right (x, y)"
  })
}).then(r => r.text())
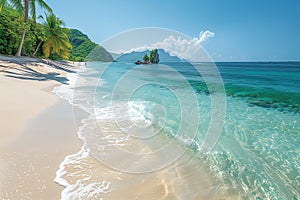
top-left (55, 62), bottom-right (300, 199)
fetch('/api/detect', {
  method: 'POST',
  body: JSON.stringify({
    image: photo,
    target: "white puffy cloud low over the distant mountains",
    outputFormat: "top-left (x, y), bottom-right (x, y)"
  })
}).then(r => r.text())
top-left (113, 30), bottom-right (215, 62)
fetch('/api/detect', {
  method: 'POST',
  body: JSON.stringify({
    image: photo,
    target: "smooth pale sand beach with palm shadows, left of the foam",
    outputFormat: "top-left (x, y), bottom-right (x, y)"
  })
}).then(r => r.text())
top-left (0, 56), bottom-right (81, 199)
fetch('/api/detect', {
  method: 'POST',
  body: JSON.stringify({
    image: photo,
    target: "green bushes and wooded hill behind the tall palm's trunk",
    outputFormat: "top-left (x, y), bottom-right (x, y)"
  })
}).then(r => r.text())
top-left (0, 6), bottom-right (113, 62)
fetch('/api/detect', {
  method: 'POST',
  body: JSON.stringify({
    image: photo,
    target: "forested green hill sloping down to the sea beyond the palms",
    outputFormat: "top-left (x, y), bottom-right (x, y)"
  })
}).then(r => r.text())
top-left (69, 29), bottom-right (113, 62)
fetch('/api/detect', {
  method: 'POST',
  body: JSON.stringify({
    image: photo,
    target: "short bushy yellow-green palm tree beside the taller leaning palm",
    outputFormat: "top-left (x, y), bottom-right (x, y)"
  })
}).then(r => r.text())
top-left (41, 13), bottom-right (72, 59)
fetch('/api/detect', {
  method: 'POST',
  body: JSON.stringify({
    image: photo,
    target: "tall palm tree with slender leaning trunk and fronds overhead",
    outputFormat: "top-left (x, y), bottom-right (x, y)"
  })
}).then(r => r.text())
top-left (0, 0), bottom-right (52, 56)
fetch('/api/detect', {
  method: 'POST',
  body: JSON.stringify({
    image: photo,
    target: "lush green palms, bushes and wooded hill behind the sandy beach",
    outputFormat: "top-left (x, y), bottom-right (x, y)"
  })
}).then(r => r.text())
top-left (0, 0), bottom-right (113, 62)
